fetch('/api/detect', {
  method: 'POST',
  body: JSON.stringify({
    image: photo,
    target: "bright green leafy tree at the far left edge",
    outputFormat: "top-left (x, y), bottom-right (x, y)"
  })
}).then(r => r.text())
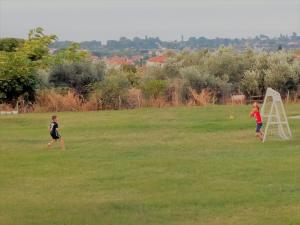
top-left (0, 28), bottom-right (56, 101)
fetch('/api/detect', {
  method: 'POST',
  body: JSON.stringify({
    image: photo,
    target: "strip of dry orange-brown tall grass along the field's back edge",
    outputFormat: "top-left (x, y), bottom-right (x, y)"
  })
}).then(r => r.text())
top-left (29, 88), bottom-right (218, 112)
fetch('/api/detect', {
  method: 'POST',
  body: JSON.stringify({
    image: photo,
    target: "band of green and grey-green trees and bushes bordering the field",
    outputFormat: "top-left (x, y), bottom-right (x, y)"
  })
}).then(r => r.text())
top-left (0, 28), bottom-right (300, 110)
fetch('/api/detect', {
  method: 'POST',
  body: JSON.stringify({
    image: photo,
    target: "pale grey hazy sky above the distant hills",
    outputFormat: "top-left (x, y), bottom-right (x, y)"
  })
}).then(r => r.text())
top-left (0, 0), bottom-right (300, 41)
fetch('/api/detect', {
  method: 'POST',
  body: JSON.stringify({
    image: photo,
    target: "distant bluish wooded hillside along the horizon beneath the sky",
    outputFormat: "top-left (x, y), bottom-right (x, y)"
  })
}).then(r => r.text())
top-left (50, 33), bottom-right (300, 56)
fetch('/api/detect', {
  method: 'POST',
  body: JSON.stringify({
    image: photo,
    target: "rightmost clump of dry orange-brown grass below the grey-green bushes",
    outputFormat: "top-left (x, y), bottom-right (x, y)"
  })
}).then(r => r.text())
top-left (188, 88), bottom-right (214, 106)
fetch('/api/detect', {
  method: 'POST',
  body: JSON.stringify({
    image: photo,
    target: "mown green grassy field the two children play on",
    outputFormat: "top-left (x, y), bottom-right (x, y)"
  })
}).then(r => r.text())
top-left (0, 105), bottom-right (300, 225)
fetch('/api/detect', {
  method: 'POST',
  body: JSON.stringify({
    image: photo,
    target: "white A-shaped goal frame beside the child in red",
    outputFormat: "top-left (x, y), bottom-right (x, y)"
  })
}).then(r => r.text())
top-left (261, 88), bottom-right (292, 142)
